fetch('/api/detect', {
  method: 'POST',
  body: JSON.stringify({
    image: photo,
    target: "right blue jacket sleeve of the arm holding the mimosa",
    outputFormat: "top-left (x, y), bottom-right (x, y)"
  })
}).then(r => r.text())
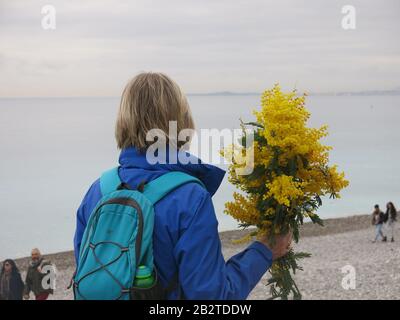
top-left (174, 192), bottom-right (272, 300)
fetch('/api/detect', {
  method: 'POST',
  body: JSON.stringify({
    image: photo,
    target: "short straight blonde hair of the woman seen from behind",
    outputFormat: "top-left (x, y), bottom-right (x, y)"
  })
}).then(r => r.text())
top-left (115, 72), bottom-right (194, 151)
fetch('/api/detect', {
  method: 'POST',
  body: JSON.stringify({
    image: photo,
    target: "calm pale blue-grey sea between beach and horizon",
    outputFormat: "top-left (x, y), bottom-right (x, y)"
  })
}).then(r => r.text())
top-left (0, 96), bottom-right (400, 259)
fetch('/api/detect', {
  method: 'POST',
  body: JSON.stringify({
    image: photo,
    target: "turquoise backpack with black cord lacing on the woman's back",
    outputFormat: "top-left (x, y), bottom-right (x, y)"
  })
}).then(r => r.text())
top-left (73, 168), bottom-right (204, 300)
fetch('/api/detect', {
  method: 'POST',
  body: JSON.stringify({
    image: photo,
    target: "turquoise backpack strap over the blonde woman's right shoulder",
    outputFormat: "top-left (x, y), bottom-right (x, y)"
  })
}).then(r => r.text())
top-left (143, 171), bottom-right (205, 205)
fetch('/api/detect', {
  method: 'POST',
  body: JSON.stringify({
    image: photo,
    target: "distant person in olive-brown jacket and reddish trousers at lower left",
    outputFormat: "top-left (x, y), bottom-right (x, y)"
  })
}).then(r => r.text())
top-left (24, 248), bottom-right (53, 300)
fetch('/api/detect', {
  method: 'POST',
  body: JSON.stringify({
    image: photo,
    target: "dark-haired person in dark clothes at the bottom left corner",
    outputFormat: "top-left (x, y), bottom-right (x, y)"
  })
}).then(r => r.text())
top-left (0, 259), bottom-right (24, 300)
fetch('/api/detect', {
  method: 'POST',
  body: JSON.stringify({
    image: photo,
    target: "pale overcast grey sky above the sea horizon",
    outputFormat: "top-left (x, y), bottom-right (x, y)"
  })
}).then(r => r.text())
top-left (0, 0), bottom-right (400, 97)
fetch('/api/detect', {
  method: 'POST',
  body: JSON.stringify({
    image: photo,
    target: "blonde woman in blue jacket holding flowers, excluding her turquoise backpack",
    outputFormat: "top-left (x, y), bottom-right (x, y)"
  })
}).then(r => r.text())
top-left (74, 73), bottom-right (291, 299)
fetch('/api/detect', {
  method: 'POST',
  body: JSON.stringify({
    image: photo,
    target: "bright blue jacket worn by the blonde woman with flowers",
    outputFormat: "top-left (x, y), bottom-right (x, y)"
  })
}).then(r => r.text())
top-left (74, 148), bottom-right (272, 300)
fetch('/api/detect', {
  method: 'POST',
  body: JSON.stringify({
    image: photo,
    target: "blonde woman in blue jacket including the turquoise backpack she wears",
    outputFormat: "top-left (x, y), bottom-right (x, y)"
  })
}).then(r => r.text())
top-left (73, 73), bottom-right (292, 300)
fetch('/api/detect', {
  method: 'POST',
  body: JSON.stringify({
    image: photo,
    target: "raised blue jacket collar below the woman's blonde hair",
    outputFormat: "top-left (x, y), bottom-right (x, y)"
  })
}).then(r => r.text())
top-left (119, 147), bottom-right (225, 196)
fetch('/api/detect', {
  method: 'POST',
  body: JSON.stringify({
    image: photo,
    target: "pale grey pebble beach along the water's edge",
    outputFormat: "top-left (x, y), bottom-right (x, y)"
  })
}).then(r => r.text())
top-left (11, 215), bottom-right (400, 300)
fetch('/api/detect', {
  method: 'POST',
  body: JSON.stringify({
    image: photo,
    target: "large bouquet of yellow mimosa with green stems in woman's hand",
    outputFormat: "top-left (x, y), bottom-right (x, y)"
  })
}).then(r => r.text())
top-left (222, 85), bottom-right (349, 299)
